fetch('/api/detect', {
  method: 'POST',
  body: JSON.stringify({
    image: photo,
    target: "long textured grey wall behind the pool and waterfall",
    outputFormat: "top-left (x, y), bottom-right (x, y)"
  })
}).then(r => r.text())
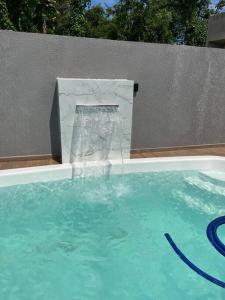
top-left (0, 31), bottom-right (225, 157)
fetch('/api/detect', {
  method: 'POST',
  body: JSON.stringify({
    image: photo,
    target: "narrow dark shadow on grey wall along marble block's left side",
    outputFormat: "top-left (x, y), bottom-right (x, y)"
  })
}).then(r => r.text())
top-left (49, 83), bottom-right (62, 162)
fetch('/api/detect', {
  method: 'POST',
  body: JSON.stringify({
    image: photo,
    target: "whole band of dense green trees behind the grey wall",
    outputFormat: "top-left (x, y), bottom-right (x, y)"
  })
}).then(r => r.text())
top-left (0, 0), bottom-right (213, 46)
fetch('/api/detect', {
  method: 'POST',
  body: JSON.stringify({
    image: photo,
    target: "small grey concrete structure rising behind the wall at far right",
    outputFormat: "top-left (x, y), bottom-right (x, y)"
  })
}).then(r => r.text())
top-left (207, 13), bottom-right (225, 48)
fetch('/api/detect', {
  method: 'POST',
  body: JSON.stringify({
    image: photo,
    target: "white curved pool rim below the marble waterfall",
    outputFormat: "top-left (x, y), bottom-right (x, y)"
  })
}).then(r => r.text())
top-left (0, 156), bottom-right (225, 187)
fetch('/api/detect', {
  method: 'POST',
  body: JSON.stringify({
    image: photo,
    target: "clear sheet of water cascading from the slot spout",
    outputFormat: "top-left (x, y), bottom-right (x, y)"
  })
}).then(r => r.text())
top-left (70, 105), bottom-right (123, 175)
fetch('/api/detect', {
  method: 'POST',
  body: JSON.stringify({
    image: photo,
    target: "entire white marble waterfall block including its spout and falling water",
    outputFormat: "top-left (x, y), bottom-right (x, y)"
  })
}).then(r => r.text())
top-left (58, 78), bottom-right (134, 163)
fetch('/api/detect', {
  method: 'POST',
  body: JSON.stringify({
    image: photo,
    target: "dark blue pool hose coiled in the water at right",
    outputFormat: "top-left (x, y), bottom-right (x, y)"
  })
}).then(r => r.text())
top-left (165, 216), bottom-right (225, 288)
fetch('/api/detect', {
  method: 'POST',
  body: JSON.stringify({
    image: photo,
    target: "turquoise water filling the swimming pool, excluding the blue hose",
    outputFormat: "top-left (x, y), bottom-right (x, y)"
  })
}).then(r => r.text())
top-left (0, 172), bottom-right (225, 300)
